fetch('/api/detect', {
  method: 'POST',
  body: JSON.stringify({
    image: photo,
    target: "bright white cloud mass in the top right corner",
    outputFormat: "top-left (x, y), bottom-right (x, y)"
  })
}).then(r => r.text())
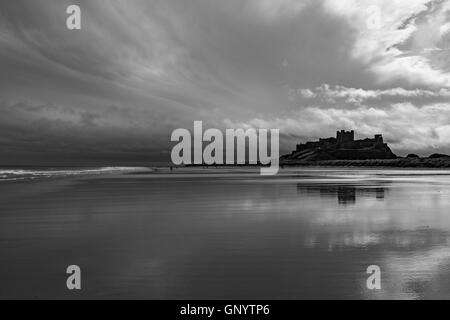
top-left (325, 0), bottom-right (450, 87)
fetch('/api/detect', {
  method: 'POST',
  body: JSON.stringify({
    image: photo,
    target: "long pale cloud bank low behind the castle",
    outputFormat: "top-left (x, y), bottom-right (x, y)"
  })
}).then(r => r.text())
top-left (225, 103), bottom-right (450, 153)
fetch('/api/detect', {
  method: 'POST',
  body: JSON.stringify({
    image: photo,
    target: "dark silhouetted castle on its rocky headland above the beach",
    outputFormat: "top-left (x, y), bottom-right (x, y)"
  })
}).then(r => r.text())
top-left (281, 130), bottom-right (397, 161)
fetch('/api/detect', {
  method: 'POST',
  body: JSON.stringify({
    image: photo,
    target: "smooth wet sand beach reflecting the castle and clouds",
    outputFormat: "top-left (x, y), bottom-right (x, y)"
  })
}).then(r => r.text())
top-left (0, 169), bottom-right (450, 299)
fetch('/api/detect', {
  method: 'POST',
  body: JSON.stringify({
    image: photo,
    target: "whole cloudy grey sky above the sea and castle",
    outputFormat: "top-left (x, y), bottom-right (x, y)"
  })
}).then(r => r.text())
top-left (0, 0), bottom-right (450, 164)
